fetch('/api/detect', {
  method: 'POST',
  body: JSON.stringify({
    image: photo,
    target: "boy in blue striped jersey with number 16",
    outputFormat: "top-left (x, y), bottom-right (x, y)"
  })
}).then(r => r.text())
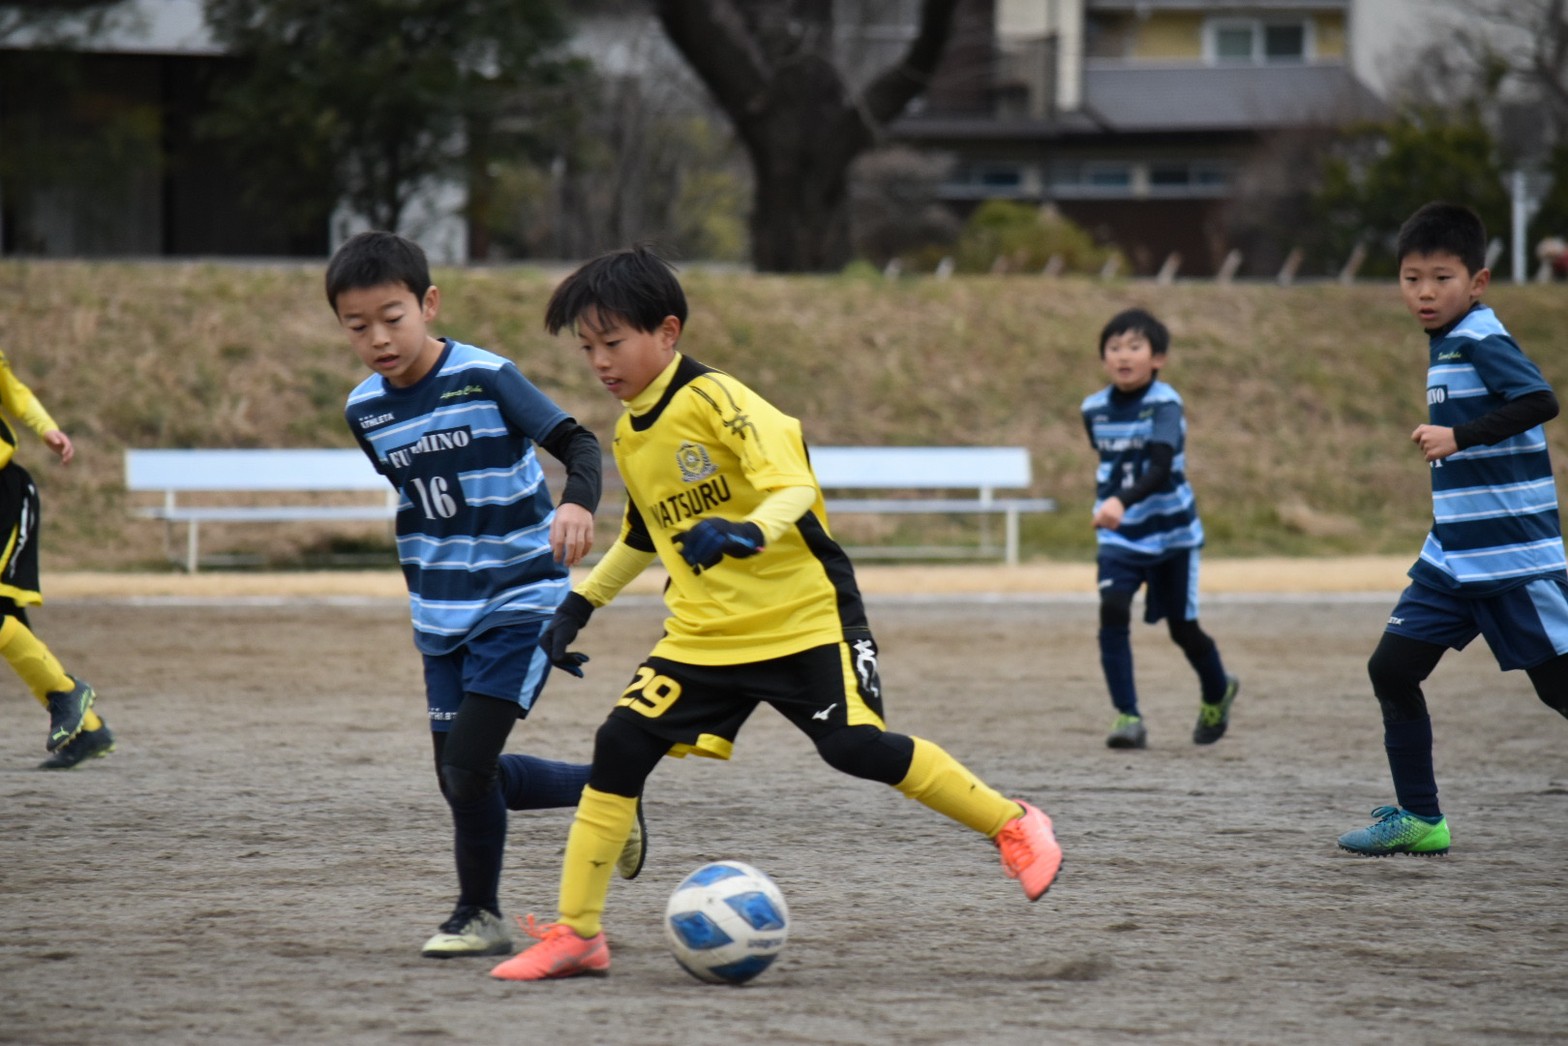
top-left (326, 232), bottom-right (643, 958)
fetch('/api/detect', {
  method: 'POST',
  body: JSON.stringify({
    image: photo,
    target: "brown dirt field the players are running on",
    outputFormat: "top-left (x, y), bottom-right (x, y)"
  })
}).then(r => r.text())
top-left (0, 566), bottom-right (1568, 1046)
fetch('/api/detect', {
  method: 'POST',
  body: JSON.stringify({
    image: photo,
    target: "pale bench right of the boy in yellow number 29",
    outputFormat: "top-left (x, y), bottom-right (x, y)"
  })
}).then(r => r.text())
top-left (811, 447), bottom-right (1057, 566)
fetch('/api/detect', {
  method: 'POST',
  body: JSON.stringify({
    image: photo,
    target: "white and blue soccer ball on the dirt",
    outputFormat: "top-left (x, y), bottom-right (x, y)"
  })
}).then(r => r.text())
top-left (665, 861), bottom-right (789, 985)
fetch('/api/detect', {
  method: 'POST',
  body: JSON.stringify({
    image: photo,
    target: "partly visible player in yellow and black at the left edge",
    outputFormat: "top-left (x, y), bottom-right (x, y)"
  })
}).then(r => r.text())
top-left (0, 353), bottom-right (114, 770)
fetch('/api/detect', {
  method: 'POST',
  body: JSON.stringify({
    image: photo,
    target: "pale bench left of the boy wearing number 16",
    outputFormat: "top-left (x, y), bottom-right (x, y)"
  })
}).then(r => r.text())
top-left (125, 450), bottom-right (398, 574)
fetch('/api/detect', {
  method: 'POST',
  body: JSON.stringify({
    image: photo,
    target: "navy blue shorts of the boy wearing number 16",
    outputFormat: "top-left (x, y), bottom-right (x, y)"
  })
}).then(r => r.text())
top-left (425, 619), bottom-right (550, 734)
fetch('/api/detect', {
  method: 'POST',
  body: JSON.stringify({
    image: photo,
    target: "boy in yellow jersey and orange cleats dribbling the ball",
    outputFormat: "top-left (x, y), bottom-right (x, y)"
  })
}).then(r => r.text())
top-left (492, 248), bottom-right (1062, 980)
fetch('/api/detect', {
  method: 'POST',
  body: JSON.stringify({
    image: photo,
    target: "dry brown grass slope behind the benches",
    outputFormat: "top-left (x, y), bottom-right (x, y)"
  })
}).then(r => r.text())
top-left (0, 262), bottom-right (1568, 571)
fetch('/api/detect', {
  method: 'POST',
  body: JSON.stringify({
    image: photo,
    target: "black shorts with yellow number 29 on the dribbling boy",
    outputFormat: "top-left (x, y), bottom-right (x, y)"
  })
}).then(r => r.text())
top-left (610, 634), bottom-right (883, 759)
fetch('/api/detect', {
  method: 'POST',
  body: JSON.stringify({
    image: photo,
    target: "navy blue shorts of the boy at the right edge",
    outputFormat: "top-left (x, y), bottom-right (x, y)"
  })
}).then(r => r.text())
top-left (1386, 577), bottom-right (1568, 671)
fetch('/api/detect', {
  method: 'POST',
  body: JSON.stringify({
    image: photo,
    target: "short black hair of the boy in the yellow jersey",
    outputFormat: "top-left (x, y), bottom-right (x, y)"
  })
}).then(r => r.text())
top-left (544, 243), bottom-right (687, 334)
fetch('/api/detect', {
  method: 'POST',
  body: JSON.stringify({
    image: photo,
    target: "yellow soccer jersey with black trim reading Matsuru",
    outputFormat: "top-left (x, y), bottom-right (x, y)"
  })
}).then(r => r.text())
top-left (615, 354), bottom-right (866, 665)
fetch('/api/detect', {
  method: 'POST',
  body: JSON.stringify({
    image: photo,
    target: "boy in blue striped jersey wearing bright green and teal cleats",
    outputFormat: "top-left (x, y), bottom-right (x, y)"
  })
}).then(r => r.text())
top-left (1339, 202), bottom-right (1568, 856)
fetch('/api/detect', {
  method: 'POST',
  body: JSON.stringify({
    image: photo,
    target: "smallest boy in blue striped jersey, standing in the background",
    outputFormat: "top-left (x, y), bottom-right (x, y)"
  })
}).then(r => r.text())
top-left (1083, 309), bottom-right (1240, 748)
